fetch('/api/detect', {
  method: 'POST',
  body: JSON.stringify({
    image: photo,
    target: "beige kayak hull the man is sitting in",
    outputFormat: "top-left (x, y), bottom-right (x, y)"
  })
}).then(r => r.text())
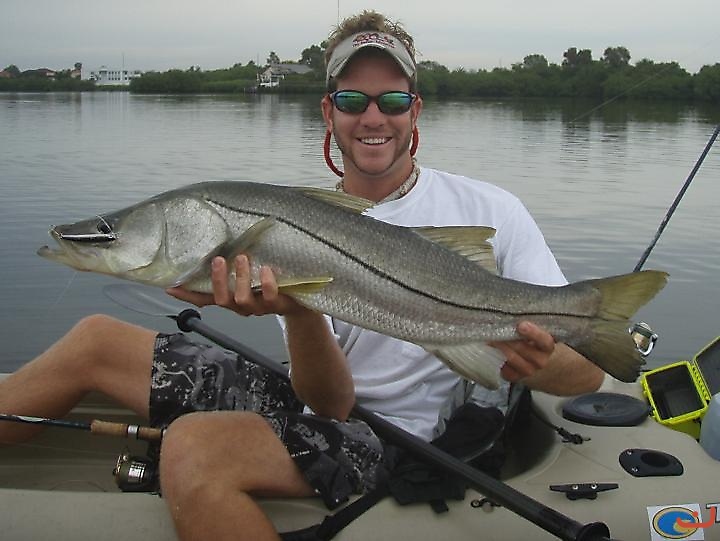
top-left (0, 377), bottom-right (720, 541)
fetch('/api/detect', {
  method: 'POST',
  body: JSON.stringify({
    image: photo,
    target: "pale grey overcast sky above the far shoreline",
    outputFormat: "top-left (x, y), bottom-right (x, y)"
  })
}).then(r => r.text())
top-left (0, 0), bottom-right (720, 73)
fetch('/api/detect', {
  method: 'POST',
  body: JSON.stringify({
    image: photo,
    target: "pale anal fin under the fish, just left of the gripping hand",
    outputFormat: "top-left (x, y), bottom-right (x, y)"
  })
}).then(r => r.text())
top-left (425, 342), bottom-right (505, 389)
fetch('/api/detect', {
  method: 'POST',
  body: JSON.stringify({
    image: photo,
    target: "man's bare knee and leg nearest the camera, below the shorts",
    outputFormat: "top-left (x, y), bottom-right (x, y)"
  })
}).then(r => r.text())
top-left (160, 411), bottom-right (314, 541)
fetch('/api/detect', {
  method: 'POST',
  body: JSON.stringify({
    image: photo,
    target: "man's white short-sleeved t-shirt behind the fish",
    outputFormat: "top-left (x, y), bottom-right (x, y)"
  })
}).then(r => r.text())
top-left (278, 168), bottom-right (567, 441)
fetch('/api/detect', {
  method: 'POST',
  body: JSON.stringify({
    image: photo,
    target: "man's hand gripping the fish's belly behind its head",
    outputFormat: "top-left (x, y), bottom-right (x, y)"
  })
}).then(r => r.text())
top-left (167, 255), bottom-right (308, 316)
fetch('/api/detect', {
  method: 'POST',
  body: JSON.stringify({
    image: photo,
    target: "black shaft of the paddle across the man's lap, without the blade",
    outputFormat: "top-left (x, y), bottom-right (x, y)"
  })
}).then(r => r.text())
top-left (173, 309), bottom-right (610, 541)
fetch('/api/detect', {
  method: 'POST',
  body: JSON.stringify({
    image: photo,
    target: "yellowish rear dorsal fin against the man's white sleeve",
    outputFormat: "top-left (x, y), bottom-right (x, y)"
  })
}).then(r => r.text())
top-left (413, 225), bottom-right (497, 274)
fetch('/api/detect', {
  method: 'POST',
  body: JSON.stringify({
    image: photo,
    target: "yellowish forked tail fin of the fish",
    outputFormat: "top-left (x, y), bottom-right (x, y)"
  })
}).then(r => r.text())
top-left (572, 270), bottom-right (668, 382)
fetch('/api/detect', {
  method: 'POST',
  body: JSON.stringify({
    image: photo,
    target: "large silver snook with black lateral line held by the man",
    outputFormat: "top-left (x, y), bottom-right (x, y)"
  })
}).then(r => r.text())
top-left (38, 182), bottom-right (667, 388)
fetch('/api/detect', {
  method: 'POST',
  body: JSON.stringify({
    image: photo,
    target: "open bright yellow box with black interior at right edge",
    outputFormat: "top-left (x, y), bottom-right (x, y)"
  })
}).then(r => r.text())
top-left (640, 336), bottom-right (720, 439)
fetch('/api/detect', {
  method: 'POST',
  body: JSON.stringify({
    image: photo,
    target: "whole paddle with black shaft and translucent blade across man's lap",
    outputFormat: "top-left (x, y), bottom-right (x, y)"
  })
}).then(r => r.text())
top-left (103, 284), bottom-right (610, 541)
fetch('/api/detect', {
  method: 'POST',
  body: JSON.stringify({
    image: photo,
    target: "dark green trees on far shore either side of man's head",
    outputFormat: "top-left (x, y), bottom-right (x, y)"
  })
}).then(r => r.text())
top-left (0, 42), bottom-right (720, 101)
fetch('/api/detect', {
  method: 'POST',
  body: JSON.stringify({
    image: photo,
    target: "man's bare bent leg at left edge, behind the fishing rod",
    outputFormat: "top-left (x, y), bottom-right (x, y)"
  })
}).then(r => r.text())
top-left (0, 315), bottom-right (156, 444)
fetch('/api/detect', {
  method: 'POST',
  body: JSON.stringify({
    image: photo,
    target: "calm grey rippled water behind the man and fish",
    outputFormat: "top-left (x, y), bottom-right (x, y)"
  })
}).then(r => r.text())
top-left (0, 93), bottom-right (720, 371)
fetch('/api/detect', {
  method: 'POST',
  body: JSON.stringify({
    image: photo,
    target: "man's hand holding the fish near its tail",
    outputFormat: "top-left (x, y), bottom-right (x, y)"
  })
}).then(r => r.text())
top-left (490, 321), bottom-right (555, 382)
